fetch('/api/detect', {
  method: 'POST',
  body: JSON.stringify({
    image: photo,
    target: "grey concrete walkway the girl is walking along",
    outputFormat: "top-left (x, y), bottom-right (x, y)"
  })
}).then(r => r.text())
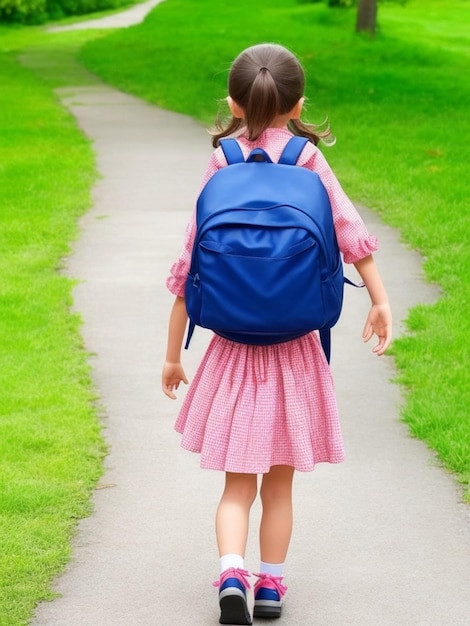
top-left (33, 3), bottom-right (470, 626)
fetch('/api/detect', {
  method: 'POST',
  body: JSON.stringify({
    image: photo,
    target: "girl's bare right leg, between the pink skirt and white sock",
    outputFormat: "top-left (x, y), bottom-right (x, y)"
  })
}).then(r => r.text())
top-left (260, 465), bottom-right (294, 564)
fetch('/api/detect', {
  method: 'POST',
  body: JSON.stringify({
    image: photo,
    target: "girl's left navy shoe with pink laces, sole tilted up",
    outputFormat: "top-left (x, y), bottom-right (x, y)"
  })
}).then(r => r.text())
top-left (214, 567), bottom-right (252, 625)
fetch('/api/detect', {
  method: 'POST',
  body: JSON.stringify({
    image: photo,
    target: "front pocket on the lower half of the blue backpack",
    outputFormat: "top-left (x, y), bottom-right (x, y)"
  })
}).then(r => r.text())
top-left (198, 237), bottom-right (325, 334)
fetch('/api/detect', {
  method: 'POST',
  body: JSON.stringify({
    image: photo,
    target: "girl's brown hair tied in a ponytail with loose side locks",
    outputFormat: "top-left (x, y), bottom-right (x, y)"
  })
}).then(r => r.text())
top-left (212, 43), bottom-right (334, 147)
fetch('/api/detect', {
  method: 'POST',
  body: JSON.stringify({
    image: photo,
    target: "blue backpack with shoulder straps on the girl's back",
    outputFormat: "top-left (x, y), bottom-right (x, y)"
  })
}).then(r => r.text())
top-left (185, 137), bottom-right (349, 360)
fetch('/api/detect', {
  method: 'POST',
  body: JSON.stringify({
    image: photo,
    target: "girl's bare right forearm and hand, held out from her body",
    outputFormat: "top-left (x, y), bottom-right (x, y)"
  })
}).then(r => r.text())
top-left (354, 254), bottom-right (392, 356)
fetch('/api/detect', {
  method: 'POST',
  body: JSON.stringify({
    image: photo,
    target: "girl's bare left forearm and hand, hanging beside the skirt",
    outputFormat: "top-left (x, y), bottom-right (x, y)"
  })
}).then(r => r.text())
top-left (162, 296), bottom-right (188, 400)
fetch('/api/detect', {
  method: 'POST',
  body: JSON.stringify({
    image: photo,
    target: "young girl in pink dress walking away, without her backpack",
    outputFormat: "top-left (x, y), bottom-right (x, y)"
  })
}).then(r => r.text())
top-left (162, 44), bottom-right (392, 624)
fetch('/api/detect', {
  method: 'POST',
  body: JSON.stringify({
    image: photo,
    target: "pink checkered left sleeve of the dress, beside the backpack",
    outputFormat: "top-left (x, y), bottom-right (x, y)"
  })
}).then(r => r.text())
top-left (166, 148), bottom-right (227, 298)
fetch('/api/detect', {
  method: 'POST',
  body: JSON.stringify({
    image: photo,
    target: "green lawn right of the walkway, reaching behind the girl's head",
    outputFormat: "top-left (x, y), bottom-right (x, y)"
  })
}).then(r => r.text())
top-left (81, 0), bottom-right (470, 494)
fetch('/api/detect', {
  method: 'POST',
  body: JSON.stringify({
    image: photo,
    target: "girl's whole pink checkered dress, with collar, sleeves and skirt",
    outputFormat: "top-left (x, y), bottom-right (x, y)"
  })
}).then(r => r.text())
top-left (167, 128), bottom-right (378, 474)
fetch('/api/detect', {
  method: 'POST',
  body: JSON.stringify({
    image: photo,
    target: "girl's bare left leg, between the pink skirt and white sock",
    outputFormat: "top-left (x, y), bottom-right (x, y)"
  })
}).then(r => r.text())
top-left (216, 472), bottom-right (258, 558)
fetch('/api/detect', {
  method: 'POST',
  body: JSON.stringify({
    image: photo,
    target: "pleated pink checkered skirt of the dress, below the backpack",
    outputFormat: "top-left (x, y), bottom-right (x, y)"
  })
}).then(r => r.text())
top-left (175, 333), bottom-right (344, 474)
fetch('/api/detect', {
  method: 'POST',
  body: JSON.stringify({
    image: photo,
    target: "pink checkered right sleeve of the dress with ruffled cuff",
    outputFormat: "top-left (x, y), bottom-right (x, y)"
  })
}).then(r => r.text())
top-left (299, 144), bottom-right (379, 263)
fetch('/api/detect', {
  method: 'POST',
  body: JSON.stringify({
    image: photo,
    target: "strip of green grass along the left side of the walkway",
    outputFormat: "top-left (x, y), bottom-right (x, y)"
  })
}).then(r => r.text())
top-left (0, 28), bottom-right (105, 626)
